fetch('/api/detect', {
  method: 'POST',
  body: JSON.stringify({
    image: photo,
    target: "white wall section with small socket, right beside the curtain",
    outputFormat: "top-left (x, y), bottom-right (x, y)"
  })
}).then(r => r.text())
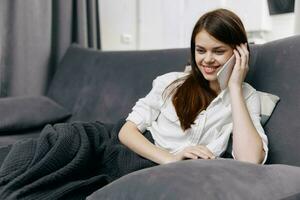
top-left (99, 0), bottom-right (138, 50)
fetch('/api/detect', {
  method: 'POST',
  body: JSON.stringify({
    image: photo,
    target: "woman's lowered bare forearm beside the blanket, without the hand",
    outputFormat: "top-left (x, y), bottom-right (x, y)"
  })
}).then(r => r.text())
top-left (119, 121), bottom-right (173, 164)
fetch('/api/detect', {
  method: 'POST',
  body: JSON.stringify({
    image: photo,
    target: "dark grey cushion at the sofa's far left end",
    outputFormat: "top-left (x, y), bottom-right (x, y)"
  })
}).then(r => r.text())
top-left (0, 96), bottom-right (71, 134)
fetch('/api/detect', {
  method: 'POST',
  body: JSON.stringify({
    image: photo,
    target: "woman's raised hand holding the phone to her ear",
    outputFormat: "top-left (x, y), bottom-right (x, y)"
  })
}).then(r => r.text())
top-left (228, 44), bottom-right (249, 89)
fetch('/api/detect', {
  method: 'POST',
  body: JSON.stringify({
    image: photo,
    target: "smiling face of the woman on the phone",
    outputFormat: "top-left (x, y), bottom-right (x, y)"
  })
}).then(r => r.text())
top-left (195, 30), bottom-right (233, 83)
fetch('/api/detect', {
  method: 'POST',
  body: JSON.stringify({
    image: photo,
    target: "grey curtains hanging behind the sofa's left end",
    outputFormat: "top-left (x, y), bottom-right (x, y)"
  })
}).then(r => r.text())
top-left (0, 0), bottom-right (101, 97)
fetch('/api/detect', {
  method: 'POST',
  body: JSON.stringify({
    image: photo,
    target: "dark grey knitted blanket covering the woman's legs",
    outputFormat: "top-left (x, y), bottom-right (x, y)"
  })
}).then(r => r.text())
top-left (0, 120), bottom-right (155, 200)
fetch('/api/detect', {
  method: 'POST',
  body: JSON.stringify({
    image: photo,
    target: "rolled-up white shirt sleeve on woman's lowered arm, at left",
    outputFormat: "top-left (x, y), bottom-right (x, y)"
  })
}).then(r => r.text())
top-left (126, 77), bottom-right (165, 132)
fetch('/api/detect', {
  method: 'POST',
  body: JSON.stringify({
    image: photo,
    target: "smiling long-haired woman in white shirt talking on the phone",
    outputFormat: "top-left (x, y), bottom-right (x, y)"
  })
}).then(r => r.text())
top-left (119, 9), bottom-right (268, 164)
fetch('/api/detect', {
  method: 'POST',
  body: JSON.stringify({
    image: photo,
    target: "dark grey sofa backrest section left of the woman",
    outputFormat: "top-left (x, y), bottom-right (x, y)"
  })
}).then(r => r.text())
top-left (47, 45), bottom-right (188, 123)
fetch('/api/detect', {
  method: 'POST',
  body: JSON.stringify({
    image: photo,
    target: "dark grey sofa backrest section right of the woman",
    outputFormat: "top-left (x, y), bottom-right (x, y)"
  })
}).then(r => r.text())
top-left (247, 36), bottom-right (300, 166)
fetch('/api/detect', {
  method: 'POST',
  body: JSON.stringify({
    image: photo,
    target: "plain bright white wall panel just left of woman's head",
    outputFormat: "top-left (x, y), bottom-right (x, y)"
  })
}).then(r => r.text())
top-left (138, 0), bottom-right (184, 49)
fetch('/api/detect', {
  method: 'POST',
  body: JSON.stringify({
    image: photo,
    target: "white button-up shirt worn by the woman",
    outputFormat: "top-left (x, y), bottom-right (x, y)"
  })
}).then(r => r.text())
top-left (126, 72), bottom-right (268, 163)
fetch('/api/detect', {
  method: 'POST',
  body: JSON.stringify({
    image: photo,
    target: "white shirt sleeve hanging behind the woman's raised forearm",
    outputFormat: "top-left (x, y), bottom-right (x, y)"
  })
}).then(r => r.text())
top-left (232, 91), bottom-right (269, 164)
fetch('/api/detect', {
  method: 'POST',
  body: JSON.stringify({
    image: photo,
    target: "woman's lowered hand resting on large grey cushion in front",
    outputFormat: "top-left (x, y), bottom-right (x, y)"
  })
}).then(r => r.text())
top-left (167, 145), bottom-right (216, 163)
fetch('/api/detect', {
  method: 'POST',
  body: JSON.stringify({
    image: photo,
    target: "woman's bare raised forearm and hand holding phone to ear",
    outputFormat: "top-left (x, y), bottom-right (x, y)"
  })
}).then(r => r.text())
top-left (228, 44), bottom-right (265, 163)
